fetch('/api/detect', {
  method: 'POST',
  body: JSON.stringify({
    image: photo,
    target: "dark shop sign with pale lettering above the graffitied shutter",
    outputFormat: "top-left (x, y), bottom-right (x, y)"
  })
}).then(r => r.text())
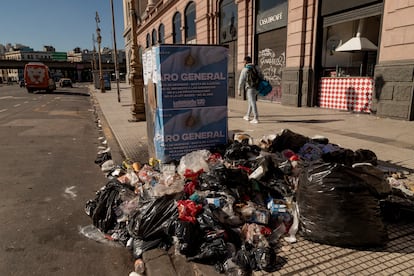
top-left (256, 2), bottom-right (288, 34)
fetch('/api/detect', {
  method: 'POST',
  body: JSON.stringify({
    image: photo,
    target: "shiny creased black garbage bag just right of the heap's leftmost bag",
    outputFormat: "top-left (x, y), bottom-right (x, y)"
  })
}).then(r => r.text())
top-left (128, 195), bottom-right (178, 241)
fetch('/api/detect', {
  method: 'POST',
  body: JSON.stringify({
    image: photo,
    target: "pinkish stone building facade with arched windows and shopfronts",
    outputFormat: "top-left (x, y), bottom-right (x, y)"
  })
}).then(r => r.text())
top-left (124, 0), bottom-right (414, 120)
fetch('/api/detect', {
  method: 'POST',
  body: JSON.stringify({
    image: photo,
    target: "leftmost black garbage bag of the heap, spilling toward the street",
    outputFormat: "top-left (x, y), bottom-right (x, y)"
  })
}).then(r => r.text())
top-left (85, 179), bottom-right (133, 233)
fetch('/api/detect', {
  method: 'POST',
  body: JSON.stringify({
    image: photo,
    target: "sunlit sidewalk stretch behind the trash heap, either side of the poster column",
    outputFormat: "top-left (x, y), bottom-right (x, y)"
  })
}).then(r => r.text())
top-left (90, 83), bottom-right (414, 172)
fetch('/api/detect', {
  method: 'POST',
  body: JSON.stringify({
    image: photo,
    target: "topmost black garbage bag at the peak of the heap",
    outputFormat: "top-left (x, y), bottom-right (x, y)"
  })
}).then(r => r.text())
top-left (269, 129), bottom-right (311, 152)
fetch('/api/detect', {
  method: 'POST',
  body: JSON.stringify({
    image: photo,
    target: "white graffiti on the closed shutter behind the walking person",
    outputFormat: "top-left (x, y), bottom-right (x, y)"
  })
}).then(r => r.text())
top-left (258, 48), bottom-right (286, 102)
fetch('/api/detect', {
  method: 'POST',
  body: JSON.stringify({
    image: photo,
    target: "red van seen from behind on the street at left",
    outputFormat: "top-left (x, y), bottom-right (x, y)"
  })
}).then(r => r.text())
top-left (24, 62), bottom-right (56, 93)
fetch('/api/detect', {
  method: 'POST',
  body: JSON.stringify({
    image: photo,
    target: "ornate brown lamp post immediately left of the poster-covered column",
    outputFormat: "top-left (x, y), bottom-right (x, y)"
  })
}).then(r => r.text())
top-left (128, 0), bottom-right (145, 122)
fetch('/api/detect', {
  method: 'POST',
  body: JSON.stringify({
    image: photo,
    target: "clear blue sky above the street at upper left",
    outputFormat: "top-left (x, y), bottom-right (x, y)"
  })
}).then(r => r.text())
top-left (0, 0), bottom-right (125, 52)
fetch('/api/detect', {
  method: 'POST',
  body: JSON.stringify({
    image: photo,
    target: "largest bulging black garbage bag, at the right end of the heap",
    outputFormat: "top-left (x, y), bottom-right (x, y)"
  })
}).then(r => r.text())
top-left (296, 163), bottom-right (387, 247)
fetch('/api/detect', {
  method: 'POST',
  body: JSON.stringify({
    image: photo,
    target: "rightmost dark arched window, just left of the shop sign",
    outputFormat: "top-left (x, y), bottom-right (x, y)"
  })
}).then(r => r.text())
top-left (219, 0), bottom-right (238, 43)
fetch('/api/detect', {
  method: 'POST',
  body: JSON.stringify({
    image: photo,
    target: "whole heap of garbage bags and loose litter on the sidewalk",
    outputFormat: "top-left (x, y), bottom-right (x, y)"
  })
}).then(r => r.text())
top-left (85, 129), bottom-right (412, 275)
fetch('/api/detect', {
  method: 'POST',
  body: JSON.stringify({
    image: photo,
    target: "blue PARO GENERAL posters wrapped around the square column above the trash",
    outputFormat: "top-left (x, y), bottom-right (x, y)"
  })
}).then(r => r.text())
top-left (150, 44), bottom-right (228, 163)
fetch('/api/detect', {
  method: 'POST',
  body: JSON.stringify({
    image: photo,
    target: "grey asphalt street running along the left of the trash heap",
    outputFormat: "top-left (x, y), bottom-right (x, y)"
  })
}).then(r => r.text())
top-left (0, 85), bottom-right (133, 276)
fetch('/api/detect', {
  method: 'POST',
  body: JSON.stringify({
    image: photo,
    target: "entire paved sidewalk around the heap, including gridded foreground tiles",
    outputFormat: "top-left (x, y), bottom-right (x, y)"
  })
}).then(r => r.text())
top-left (90, 83), bottom-right (414, 275)
